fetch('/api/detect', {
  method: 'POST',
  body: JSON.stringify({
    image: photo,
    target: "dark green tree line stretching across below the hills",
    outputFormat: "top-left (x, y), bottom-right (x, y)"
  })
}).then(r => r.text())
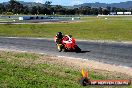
top-left (0, 0), bottom-right (132, 15)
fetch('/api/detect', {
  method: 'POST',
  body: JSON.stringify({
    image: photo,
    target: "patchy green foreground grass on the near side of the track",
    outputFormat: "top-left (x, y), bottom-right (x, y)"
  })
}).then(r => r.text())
top-left (0, 51), bottom-right (130, 88)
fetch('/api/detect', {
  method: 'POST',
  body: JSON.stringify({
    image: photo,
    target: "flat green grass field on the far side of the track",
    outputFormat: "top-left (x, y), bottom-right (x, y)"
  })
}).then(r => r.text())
top-left (0, 16), bottom-right (132, 41)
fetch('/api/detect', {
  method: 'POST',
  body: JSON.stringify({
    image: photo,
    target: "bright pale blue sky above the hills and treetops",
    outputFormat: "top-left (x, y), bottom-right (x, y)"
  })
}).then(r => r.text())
top-left (0, 0), bottom-right (132, 6)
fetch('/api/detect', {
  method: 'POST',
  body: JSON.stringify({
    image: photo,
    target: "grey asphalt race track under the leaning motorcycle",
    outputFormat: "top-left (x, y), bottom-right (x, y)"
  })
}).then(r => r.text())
top-left (0, 37), bottom-right (132, 67)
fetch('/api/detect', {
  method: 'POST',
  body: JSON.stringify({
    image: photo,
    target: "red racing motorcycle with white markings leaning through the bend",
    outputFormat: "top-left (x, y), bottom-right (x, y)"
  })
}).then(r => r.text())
top-left (55, 35), bottom-right (81, 52)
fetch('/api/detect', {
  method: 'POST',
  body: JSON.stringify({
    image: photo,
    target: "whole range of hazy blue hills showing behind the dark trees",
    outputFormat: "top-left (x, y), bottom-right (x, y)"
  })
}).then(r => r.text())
top-left (2, 1), bottom-right (132, 9)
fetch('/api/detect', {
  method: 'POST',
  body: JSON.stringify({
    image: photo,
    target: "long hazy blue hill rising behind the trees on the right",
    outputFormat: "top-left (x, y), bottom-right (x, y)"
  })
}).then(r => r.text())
top-left (74, 1), bottom-right (132, 9)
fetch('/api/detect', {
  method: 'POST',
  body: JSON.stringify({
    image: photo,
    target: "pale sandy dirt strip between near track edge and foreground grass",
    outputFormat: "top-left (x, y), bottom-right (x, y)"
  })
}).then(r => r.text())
top-left (36, 56), bottom-right (132, 79)
